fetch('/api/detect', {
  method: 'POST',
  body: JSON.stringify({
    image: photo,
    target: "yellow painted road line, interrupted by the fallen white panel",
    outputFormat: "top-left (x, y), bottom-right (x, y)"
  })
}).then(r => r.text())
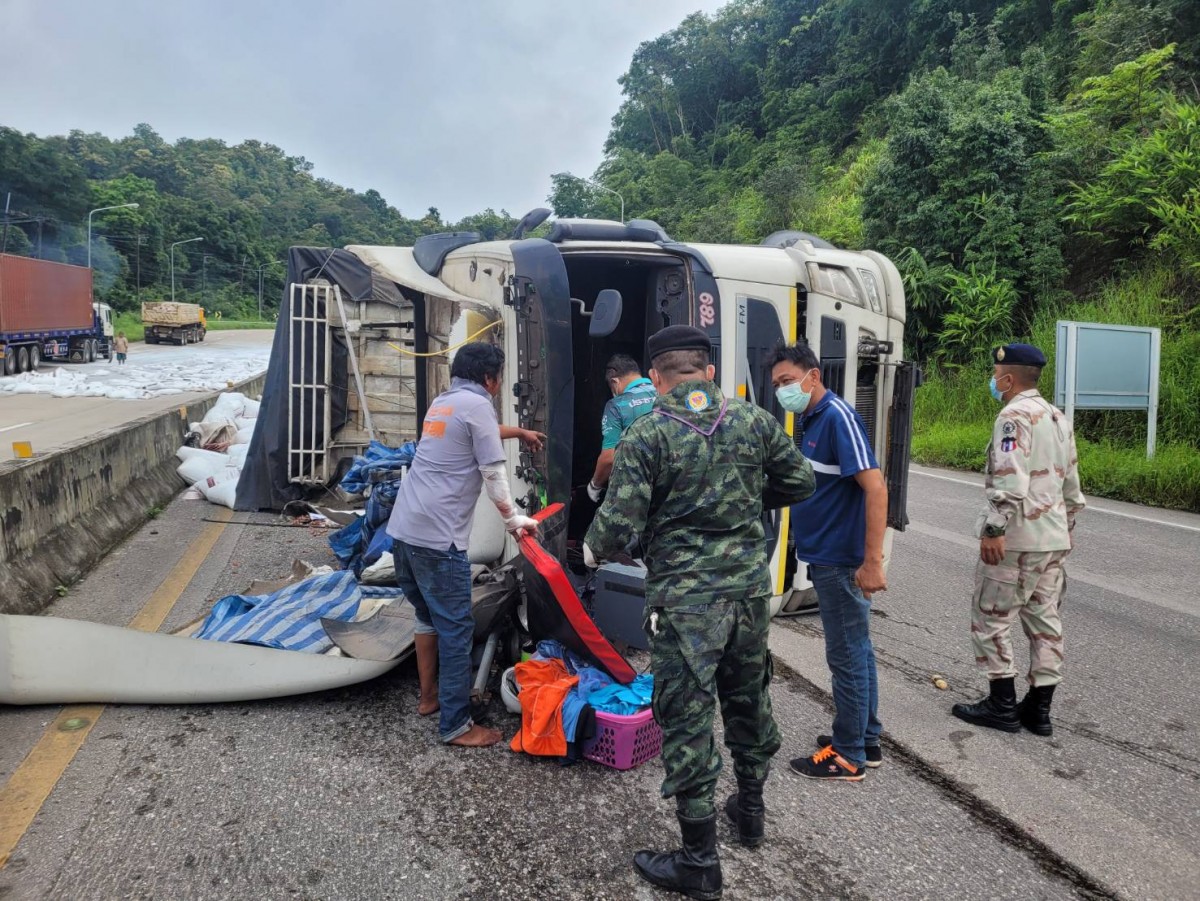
top-left (0, 507), bottom-right (233, 870)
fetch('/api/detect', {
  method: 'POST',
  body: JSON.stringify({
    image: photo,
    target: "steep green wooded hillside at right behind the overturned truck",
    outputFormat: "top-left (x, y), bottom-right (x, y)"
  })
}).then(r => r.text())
top-left (551, 0), bottom-right (1200, 510)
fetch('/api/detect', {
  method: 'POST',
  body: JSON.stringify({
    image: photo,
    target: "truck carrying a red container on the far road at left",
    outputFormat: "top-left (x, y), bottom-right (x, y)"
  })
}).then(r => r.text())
top-left (0, 253), bottom-right (113, 376)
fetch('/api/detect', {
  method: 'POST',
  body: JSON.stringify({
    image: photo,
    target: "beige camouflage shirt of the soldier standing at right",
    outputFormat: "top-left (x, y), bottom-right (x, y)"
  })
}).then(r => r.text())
top-left (979, 389), bottom-right (1085, 551)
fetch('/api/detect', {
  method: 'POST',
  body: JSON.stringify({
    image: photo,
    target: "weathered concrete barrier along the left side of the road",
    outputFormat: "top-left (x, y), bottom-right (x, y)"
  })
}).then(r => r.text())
top-left (0, 373), bottom-right (266, 613)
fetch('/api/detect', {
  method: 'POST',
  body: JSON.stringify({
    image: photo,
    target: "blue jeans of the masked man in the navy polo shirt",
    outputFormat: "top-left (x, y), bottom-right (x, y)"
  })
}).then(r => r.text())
top-left (809, 565), bottom-right (883, 767)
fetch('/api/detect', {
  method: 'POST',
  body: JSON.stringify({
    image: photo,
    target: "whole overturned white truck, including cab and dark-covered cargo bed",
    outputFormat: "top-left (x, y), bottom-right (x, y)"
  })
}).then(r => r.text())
top-left (238, 220), bottom-right (919, 612)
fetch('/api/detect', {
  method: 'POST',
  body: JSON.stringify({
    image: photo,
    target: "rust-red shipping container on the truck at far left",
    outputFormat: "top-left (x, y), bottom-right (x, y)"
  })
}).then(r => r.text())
top-left (0, 253), bottom-right (94, 335)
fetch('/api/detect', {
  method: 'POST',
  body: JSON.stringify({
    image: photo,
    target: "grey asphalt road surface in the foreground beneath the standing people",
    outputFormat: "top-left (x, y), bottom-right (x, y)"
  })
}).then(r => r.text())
top-left (0, 470), bottom-right (1200, 901)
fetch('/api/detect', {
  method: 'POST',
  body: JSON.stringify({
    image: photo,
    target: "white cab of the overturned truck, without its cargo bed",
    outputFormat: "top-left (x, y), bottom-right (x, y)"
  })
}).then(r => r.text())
top-left (314, 220), bottom-right (916, 612)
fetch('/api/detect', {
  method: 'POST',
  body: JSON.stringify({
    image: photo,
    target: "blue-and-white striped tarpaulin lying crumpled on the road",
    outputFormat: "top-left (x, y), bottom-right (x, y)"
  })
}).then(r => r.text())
top-left (196, 570), bottom-right (362, 654)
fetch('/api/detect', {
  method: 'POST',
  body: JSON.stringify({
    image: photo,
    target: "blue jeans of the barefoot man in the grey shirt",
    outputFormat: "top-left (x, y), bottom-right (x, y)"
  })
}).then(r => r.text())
top-left (391, 541), bottom-right (475, 741)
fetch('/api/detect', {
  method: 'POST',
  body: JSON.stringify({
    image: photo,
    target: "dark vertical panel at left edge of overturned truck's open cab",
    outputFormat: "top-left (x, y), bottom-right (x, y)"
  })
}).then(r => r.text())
top-left (504, 238), bottom-right (575, 559)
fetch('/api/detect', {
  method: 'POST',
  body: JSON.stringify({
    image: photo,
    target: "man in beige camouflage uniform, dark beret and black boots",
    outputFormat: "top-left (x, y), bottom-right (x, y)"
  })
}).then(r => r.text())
top-left (952, 344), bottom-right (1084, 735)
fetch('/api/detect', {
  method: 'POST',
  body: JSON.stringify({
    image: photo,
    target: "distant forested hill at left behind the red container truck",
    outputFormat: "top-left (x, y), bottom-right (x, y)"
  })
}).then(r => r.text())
top-left (0, 125), bottom-right (516, 319)
